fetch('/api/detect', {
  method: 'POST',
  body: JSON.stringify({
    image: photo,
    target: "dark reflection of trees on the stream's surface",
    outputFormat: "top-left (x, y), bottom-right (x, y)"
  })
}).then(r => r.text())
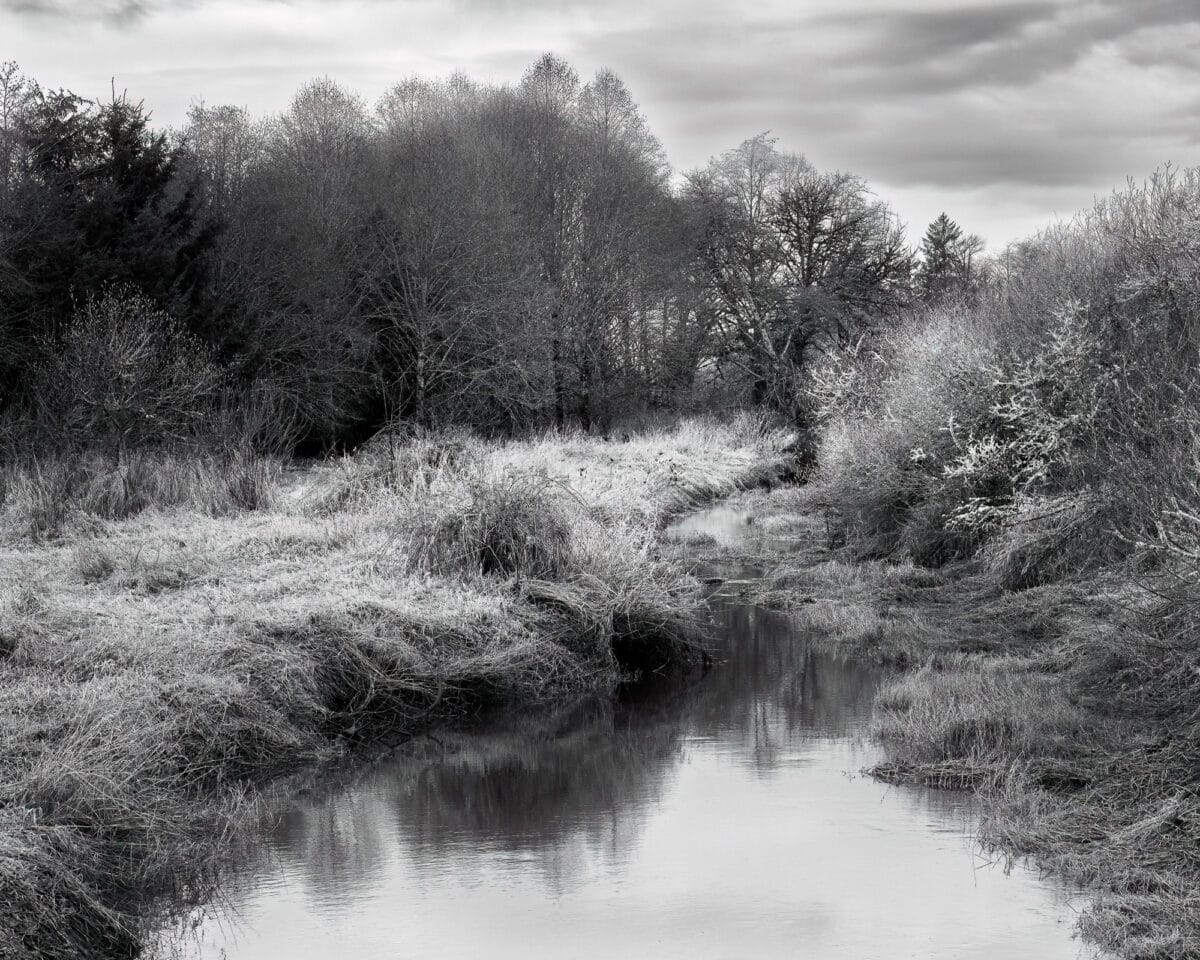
top-left (234, 604), bottom-right (875, 906)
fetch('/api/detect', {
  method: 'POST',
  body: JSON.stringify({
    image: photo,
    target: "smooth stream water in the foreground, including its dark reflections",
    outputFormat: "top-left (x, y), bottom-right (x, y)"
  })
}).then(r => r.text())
top-left (164, 506), bottom-right (1087, 960)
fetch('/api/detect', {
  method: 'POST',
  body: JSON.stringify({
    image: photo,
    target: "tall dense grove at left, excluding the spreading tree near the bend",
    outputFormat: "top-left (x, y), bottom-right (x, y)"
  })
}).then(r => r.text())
top-left (0, 61), bottom-right (702, 444)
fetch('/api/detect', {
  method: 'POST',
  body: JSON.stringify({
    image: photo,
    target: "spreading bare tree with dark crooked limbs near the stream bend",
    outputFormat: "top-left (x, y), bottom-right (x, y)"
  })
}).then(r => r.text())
top-left (686, 134), bottom-right (911, 456)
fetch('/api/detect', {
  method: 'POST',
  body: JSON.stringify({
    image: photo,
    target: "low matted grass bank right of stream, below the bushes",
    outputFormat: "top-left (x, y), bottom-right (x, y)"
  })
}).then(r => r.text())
top-left (686, 488), bottom-right (1200, 960)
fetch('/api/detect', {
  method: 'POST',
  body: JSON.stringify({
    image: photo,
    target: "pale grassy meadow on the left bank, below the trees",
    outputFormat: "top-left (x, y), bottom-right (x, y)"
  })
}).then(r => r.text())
top-left (0, 420), bottom-right (784, 958)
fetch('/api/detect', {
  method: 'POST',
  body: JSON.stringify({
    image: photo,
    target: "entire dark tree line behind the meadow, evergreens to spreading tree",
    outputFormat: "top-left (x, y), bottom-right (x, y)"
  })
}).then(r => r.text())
top-left (0, 54), bottom-right (985, 458)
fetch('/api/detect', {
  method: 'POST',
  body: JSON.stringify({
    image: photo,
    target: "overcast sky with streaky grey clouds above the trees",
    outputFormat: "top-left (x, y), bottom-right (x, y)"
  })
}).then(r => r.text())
top-left (0, 0), bottom-right (1200, 251)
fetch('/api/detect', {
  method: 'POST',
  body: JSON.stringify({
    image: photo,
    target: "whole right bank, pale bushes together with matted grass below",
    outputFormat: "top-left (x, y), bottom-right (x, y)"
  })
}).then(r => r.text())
top-left (816, 169), bottom-right (1200, 958)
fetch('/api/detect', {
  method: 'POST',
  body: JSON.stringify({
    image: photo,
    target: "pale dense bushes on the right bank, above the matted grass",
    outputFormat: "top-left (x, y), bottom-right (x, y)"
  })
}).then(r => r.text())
top-left (814, 170), bottom-right (1200, 578)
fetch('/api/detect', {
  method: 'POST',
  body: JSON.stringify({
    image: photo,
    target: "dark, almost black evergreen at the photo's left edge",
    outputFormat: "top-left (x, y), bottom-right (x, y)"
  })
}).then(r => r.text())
top-left (0, 91), bottom-right (217, 407)
